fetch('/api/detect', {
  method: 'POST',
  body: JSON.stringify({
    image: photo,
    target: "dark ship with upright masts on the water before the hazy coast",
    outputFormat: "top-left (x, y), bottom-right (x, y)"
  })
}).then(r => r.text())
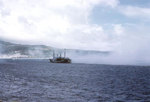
top-left (49, 50), bottom-right (71, 63)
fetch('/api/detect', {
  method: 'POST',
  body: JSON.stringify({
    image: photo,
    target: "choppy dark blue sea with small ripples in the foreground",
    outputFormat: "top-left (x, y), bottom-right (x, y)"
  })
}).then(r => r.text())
top-left (0, 60), bottom-right (150, 102)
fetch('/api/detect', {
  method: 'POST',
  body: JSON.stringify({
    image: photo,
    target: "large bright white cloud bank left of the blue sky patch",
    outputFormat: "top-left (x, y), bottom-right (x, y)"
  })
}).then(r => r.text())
top-left (0, 0), bottom-right (119, 50)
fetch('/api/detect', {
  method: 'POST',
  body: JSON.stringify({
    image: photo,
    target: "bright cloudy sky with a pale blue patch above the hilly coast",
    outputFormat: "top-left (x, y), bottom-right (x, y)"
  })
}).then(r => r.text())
top-left (0, 0), bottom-right (150, 53)
